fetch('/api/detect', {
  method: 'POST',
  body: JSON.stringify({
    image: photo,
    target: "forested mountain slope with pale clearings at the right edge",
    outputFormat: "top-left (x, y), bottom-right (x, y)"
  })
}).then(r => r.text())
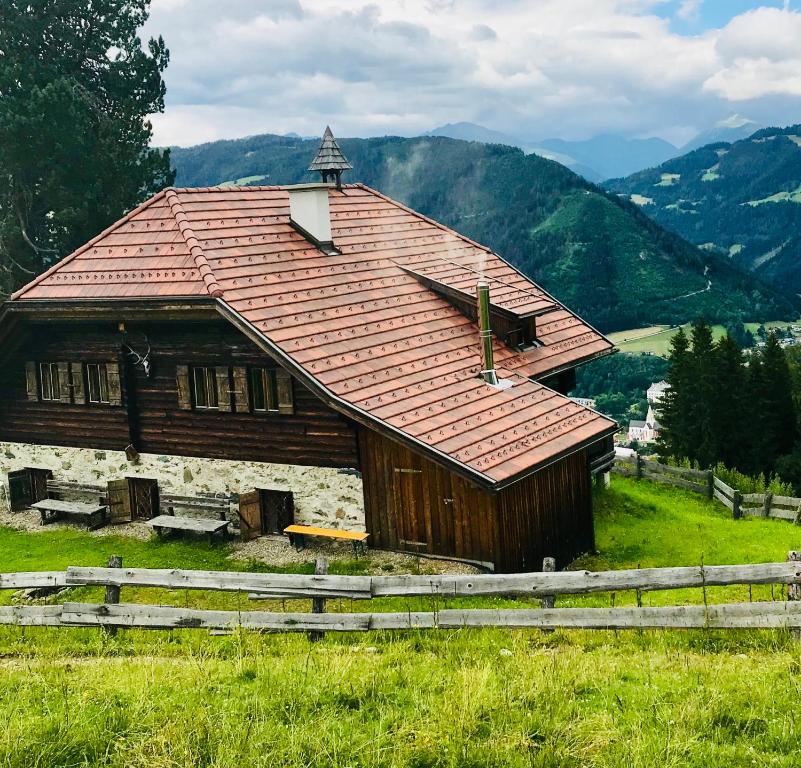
top-left (607, 125), bottom-right (801, 293)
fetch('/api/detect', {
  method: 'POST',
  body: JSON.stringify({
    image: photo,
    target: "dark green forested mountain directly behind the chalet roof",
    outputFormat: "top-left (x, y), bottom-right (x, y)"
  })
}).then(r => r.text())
top-left (172, 135), bottom-right (794, 331)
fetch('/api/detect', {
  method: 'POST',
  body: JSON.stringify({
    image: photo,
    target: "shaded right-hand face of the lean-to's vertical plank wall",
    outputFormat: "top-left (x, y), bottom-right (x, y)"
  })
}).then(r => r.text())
top-left (498, 451), bottom-right (595, 571)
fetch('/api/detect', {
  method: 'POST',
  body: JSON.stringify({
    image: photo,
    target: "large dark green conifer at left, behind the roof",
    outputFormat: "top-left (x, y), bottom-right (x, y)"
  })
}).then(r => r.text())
top-left (0, 0), bottom-right (174, 293)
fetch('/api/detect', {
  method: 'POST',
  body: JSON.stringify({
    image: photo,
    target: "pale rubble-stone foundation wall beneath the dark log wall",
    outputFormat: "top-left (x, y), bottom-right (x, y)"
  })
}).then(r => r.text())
top-left (0, 442), bottom-right (365, 531)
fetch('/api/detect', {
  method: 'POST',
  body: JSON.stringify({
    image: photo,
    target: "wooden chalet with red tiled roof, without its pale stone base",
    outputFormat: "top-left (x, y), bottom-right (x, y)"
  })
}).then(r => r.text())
top-left (0, 130), bottom-right (616, 571)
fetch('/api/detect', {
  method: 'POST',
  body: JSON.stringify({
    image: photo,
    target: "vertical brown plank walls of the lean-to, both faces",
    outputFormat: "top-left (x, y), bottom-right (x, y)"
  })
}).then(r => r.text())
top-left (359, 429), bottom-right (594, 572)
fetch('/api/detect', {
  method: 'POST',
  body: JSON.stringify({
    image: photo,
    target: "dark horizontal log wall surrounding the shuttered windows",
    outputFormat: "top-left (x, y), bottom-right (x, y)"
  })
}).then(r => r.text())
top-left (0, 320), bottom-right (358, 468)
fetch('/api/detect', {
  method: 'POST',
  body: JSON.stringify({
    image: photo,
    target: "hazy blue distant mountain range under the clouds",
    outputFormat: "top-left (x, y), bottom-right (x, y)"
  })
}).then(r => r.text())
top-left (426, 115), bottom-right (759, 183)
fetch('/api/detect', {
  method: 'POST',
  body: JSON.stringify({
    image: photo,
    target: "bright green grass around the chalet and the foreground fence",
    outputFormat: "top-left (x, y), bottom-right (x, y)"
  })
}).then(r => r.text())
top-left (0, 478), bottom-right (801, 768)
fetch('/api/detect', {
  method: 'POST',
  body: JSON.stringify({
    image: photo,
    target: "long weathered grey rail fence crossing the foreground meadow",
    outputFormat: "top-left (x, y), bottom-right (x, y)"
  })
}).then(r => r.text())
top-left (0, 552), bottom-right (801, 638)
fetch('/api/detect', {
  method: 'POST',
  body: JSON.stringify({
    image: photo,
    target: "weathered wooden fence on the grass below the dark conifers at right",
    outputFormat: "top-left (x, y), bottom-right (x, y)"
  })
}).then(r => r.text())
top-left (612, 453), bottom-right (801, 524)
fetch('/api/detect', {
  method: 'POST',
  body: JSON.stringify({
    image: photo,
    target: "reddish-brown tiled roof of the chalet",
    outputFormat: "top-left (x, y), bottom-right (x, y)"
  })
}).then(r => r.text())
top-left (13, 185), bottom-right (615, 484)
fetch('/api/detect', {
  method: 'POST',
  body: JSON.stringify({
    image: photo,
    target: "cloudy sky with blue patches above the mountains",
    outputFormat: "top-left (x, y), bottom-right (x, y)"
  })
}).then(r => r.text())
top-left (145, 0), bottom-right (801, 146)
